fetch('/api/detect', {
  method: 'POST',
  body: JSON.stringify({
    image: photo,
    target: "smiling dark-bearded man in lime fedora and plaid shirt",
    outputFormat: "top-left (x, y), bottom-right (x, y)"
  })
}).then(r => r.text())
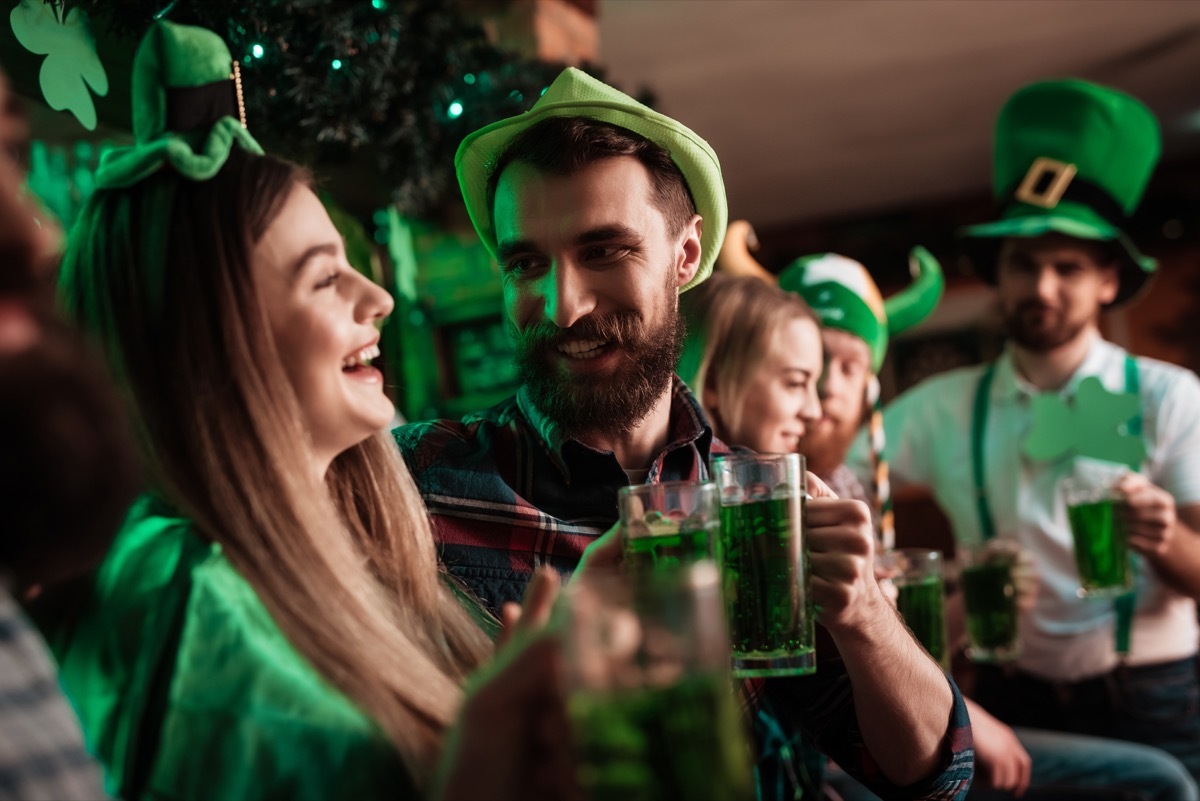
top-left (396, 70), bottom-right (972, 797)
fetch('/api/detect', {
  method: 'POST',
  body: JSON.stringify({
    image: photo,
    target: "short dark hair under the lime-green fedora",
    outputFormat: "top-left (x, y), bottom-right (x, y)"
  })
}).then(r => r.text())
top-left (487, 116), bottom-right (696, 236)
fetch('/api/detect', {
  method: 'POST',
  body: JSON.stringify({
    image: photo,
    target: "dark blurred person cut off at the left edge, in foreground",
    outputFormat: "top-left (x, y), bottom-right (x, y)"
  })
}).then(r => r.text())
top-left (0, 71), bottom-right (137, 800)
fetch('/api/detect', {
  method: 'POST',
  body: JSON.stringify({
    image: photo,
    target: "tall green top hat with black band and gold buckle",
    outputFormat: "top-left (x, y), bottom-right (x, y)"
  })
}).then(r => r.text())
top-left (960, 80), bottom-right (1162, 306)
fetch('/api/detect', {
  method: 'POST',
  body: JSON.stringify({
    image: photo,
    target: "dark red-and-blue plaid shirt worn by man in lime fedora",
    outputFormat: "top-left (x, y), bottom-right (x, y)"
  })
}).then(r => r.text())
top-left (394, 378), bottom-right (974, 801)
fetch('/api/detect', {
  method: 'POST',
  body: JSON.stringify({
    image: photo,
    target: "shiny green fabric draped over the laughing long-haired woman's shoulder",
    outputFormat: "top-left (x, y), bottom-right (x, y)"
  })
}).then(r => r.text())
top-left (38, 499), bottom-right (418, 801)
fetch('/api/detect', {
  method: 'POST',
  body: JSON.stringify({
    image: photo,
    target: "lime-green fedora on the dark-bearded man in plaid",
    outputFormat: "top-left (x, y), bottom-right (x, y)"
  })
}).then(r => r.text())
top-left (454, 67), bottom-right (728, 291)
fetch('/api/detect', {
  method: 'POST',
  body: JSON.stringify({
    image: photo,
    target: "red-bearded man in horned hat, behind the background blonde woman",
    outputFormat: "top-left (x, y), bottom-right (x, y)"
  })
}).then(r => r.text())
top-left (779, 247), bottom-right (946, 548)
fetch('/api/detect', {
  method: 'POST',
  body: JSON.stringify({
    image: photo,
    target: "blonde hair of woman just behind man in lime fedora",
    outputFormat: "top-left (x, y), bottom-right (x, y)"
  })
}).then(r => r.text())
top-left (678, 272), bottom-right (820, 439)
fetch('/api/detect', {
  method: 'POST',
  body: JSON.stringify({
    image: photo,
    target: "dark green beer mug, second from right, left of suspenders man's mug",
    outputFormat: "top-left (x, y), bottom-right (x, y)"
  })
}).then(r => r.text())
top-left (961, 540), bottom-right (1020, 662)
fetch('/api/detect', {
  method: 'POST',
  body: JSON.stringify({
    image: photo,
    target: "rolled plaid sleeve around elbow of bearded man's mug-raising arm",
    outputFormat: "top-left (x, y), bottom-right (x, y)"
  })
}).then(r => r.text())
top-left (742, 634), bottom-right (974, 801)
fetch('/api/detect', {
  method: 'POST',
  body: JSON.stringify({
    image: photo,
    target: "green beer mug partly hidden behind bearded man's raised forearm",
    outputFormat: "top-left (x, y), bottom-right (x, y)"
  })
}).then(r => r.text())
top-left (882, 548), bottom-right (950, 668)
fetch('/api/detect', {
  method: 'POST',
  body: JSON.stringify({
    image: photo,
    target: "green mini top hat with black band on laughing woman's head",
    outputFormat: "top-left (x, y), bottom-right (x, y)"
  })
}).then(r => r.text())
top-left (96, 22), bottom-right (263, 189)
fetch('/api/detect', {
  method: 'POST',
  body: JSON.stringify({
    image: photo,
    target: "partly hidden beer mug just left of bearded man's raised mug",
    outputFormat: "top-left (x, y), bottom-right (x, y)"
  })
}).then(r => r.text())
top-left (617, 481), bottom-right (720, 574)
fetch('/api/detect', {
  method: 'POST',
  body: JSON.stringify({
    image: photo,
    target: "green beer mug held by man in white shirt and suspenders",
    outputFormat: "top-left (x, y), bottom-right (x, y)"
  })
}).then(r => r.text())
top-left (1062, 477), bottom-right (1133, 598)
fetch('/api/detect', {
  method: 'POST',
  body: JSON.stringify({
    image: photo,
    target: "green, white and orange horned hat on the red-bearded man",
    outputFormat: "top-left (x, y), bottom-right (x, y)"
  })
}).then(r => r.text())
top-left (779, 247), bottom-right (946, 373)
